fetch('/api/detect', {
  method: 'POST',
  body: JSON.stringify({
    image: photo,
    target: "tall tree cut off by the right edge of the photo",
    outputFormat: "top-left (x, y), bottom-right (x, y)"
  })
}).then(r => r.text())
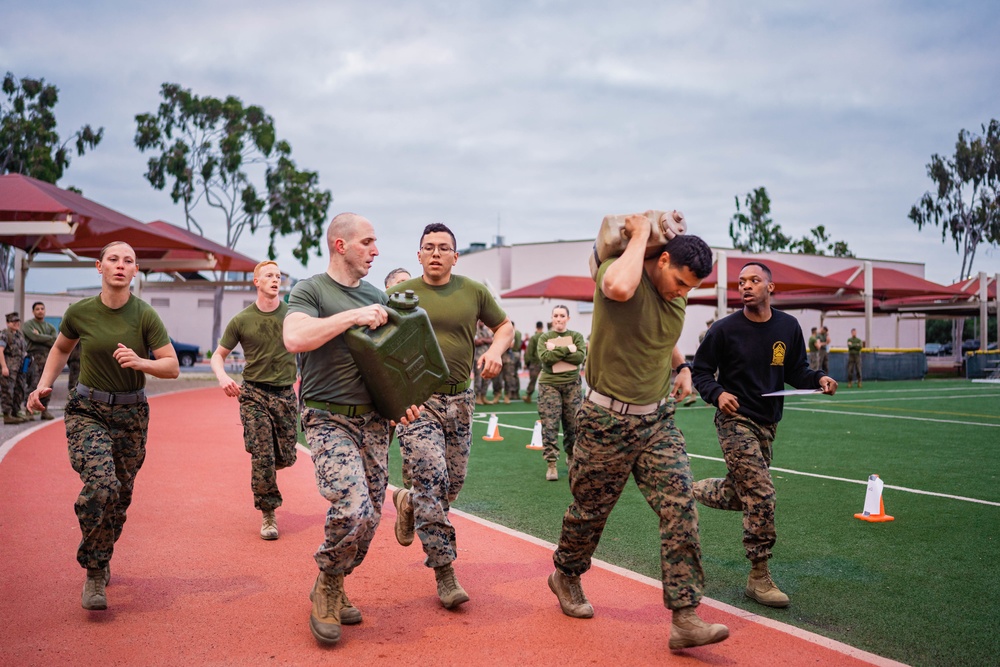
top-left (909, 120), bottom-right (1000, 278)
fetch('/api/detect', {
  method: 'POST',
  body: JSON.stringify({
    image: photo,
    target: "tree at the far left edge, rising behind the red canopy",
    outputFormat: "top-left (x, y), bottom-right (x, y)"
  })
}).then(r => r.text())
top-left (0, 72), bottom-right (104, 290)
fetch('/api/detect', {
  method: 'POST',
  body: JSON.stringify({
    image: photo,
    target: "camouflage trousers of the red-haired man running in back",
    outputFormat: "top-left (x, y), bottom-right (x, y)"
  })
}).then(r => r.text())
top-left (240, 382), bottom-right (298, 512)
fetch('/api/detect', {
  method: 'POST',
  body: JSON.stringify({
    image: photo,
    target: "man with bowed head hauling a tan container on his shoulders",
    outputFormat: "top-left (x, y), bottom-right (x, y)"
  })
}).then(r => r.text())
top-left (549, 214), bottom-right (729, 649)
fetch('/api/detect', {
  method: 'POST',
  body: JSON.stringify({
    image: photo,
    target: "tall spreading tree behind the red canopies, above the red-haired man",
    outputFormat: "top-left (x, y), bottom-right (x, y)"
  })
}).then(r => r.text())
top-left (135, 83), bottom-right (333, 347)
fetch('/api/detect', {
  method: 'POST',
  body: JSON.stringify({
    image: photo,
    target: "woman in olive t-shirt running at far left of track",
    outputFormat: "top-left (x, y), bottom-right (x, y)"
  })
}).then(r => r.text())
top-left (28, 242), bottom-right (180, 610)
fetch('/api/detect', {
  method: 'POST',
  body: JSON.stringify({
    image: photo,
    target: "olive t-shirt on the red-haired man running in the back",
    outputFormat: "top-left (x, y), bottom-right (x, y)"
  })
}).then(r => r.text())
top-left (219, 301), bottom-right (295, 387)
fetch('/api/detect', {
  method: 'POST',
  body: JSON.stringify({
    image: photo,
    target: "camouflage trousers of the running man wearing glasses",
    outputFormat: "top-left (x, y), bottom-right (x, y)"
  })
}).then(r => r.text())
top-left (399, 390), bottom-right (475, 567)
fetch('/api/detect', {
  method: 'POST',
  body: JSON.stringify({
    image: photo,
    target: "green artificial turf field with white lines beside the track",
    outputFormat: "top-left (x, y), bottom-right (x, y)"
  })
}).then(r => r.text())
top-left (380, 380), bottom-right (1000, 665)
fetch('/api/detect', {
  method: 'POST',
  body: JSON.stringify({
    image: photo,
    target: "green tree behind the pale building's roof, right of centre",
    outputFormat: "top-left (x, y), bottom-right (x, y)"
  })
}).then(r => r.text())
top-left (729, 187), bottom-right (854, 257)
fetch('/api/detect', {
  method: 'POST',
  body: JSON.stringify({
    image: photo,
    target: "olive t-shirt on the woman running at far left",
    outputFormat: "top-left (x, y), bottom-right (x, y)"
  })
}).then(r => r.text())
top-left (59, 295), bottom-right (170, 392)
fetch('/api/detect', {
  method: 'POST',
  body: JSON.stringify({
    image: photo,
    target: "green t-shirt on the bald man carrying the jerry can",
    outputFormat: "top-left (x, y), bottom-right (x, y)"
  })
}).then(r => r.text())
top-left (288, 273), bottom-right (389, 405)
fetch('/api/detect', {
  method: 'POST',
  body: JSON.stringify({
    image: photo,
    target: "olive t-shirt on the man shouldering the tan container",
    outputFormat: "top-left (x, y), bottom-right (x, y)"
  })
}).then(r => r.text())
top-left (587, 258), bottom-right (687, 405)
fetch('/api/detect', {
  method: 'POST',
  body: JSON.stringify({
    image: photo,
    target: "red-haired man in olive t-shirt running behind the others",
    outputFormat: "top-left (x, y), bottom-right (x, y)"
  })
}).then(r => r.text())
top-left (212, 260), bottom-right (298, 540)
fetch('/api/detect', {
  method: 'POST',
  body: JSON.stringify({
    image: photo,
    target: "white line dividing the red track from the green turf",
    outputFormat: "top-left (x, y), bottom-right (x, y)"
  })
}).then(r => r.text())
top-left (434, 496), bottom-right (906, 667)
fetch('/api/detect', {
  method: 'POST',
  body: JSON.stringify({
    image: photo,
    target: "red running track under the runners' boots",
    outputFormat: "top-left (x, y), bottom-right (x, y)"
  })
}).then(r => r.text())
top-left (0, 388), bottom-right (898, 667)
